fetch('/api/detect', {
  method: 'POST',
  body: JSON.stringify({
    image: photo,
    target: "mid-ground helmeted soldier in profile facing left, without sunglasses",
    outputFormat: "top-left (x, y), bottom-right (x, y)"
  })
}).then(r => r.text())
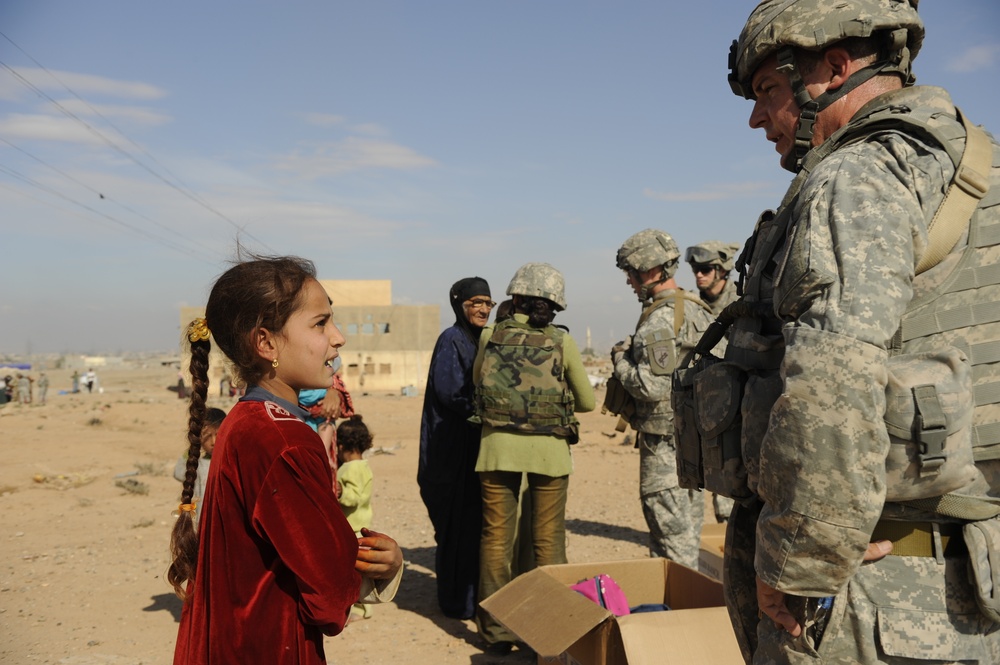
top-left (611, 229), bottom-right (711, 568)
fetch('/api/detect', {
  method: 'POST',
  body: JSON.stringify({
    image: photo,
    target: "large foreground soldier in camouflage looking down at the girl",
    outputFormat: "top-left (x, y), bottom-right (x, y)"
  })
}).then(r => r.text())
top-left (725, 0), bottom-right (1000, 663)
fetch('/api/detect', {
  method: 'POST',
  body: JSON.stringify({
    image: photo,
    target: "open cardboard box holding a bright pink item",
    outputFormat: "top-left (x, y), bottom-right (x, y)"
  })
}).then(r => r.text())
top-left (481, 558), bottom-right (743, 665)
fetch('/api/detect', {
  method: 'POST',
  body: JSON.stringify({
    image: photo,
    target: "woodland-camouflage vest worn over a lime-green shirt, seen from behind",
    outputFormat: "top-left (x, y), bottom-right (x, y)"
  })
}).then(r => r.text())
top-left (476, 319), bottom-right (580, 443)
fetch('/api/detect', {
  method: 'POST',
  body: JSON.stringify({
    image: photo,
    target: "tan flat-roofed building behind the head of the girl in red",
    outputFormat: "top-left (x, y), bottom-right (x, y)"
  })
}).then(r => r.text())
top-left (181, 280), bottom-right (441, 395)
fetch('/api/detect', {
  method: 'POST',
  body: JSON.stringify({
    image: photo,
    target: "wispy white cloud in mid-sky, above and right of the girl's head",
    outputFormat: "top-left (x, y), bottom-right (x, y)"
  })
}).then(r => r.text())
top-left (275, 137), bottom-right (436, 180)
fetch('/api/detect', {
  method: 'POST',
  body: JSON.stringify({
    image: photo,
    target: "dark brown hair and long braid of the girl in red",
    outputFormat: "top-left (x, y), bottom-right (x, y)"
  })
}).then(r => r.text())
top-left (167, 256), bottom-right (316, 599)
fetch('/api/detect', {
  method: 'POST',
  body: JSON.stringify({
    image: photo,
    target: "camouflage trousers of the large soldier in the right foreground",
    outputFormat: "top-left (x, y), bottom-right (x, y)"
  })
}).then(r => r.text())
top-left (724, 504), bottom-right (1000, 665)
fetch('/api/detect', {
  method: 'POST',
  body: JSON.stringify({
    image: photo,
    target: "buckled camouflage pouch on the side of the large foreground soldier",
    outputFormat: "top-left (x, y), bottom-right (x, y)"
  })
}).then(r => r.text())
top-left (884, 347), bottom-right (977, 501)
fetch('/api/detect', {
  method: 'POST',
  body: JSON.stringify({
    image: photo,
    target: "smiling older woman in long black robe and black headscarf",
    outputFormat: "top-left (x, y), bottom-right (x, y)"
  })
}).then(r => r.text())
top-left (417, 277), bottom-right (496, 619)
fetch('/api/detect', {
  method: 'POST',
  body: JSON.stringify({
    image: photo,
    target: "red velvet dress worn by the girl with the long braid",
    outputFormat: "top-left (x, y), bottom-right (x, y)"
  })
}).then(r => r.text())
top-left (174, 401), bottom-right (361, 665)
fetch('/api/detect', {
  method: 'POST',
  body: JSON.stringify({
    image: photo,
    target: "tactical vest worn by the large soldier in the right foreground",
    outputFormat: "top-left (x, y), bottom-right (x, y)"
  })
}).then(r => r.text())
top-left (726, 88), bottom-right (1000, 508)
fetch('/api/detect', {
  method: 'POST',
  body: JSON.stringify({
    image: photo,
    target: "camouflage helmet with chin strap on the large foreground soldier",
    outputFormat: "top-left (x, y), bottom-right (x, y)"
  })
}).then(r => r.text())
top-left (729, 0), bottom-right (924, 170)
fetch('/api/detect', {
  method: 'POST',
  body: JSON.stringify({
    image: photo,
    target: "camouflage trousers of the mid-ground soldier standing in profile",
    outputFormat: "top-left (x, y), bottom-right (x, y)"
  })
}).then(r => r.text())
top-left (638, 432), bottom-right (705, 570)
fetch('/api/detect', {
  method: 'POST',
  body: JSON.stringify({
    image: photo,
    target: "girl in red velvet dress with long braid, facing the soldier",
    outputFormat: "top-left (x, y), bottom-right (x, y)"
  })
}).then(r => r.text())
top-left (167, 257), bottom-right (403, 665)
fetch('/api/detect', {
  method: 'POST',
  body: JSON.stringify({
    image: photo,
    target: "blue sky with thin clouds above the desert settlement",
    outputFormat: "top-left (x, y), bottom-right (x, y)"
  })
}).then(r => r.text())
top-left (0, 0), bottom-right (1000, 354)
